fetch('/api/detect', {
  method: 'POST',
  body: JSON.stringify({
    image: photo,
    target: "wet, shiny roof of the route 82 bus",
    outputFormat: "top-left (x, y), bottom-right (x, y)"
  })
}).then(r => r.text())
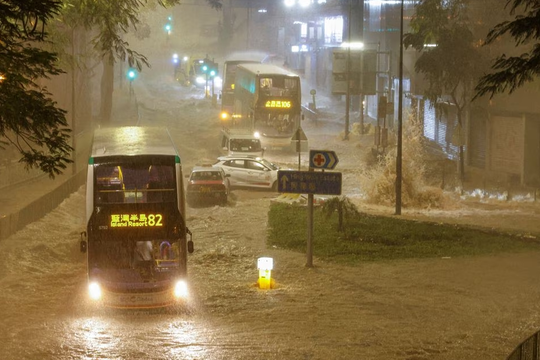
top-left (92, 126), bottom-right (178, 157)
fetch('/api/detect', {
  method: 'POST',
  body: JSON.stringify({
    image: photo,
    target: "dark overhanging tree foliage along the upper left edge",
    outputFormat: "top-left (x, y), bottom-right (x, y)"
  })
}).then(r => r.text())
top-left (0, 0), bottom-right (73, 178)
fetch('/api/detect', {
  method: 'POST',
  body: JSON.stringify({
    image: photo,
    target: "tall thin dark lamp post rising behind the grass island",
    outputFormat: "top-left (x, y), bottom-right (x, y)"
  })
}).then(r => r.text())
top-left (396, 0), bottom-right (403, 215)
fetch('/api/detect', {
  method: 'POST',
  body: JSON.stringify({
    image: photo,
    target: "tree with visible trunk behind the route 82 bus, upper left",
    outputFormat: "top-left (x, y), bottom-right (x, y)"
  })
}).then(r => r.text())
top-left (64, 0), bottom-right (221, 124)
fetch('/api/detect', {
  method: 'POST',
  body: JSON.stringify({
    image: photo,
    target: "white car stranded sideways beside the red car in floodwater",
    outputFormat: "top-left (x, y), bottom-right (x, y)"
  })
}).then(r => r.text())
top-left (213, 155), bottom-right (279, 191)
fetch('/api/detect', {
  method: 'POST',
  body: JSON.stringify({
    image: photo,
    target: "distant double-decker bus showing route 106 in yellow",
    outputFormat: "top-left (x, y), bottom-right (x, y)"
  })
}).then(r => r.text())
top-left (232, 63), bottom-right (305, 149)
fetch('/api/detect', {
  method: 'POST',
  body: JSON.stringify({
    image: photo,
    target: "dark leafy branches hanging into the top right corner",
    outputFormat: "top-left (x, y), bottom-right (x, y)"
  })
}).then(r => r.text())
top-left (475, 0), bottom-right (540, 98)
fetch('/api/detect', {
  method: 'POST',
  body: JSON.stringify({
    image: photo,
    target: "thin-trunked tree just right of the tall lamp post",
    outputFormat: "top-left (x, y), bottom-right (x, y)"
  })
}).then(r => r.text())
top-left (403, 0), bottom-right (483, 184)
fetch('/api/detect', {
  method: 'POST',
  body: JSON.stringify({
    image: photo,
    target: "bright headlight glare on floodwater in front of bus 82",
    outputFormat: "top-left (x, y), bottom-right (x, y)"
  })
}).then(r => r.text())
top-left (63, 310), bottom-right (214, 359)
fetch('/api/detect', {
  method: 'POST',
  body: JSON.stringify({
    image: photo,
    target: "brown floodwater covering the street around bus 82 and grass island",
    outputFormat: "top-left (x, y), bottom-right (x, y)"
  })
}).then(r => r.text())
top-left (0, 26), bottom-right (540, 360)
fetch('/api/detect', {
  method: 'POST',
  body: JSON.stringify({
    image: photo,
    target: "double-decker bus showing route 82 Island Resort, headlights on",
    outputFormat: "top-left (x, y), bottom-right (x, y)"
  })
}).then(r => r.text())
top-left (80, 126), bottom-right (193, 308)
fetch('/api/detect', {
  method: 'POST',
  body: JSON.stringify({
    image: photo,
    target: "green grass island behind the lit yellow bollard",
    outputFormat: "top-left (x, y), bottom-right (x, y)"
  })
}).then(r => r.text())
top-left (268, 203), bottom-right (540, 264)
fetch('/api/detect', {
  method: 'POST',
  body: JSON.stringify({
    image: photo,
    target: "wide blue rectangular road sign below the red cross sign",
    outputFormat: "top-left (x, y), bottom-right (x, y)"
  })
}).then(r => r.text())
top-left (278, 170), bottom-right (341, 195)
